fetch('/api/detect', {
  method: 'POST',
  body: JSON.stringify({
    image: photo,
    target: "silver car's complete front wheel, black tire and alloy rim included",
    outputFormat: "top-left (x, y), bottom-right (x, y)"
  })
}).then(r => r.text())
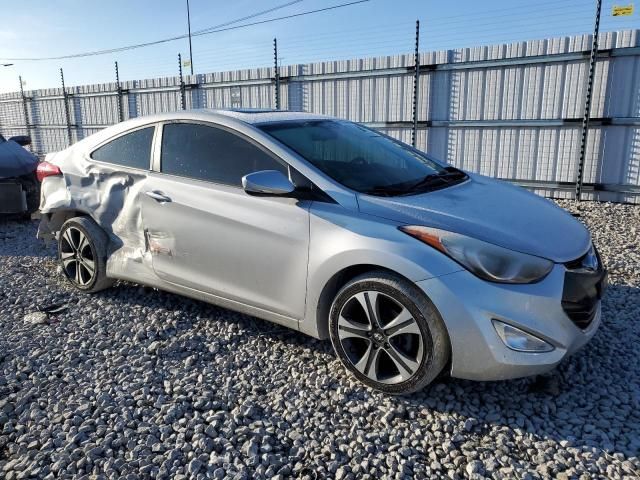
top-left (329, 271), bottom-right (450, 395)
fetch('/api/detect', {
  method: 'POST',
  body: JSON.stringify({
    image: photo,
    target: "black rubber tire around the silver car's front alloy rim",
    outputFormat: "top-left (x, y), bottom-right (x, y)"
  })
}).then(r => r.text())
top-left (329, 278), bottom-right (440, 395)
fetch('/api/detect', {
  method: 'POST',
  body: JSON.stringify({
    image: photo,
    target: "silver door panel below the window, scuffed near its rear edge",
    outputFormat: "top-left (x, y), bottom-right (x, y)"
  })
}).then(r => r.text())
top-left (140, 174), bottom-right (311, 318)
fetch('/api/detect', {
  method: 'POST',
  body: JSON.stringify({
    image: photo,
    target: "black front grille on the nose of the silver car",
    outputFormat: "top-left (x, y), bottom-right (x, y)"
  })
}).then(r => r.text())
top-left (562, 247), bottom-right (607, 330)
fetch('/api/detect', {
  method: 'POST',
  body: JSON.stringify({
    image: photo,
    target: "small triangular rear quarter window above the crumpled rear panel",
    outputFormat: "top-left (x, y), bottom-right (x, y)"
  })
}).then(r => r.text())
top-left (91, 127), bottom-right (155, 170)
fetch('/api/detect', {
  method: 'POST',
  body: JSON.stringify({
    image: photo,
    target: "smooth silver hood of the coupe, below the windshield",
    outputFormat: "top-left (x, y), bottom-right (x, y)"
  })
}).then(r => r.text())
top-left (358, 174), bottom-right (591, 262)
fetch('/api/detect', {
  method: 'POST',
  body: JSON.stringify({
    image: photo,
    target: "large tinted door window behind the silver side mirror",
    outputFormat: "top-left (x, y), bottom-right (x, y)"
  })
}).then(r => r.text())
top-left (161, 123), bottom-right (287, 186)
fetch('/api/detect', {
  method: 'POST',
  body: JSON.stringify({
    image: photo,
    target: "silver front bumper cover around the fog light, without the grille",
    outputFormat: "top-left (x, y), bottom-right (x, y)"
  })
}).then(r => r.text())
top-left (417, 265), bottom-right (602, 380)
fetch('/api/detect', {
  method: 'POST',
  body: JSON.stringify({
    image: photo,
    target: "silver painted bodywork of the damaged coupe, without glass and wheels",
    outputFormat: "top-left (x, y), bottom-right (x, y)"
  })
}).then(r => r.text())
top-left (39, 110), bottom-right (595, 379)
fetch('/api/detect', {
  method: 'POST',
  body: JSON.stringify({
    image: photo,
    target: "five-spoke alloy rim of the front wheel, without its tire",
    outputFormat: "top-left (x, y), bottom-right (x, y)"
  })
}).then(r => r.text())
top-left (338, 290), bottom-right (424, 384)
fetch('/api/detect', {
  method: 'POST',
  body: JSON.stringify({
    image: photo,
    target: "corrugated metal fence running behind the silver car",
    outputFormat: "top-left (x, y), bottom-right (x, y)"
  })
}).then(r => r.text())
top-left (0, 30), bottom-right (640, 203)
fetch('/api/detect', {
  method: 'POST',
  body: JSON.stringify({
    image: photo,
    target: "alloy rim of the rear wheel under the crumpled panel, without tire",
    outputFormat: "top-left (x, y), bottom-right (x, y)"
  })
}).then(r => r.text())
top-left (60, 227), bottom-right (96, 287)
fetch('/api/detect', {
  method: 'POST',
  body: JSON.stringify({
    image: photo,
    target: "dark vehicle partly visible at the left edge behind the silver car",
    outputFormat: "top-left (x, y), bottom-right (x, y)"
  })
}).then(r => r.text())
top-left (0, 135), bottom-right (40, 217)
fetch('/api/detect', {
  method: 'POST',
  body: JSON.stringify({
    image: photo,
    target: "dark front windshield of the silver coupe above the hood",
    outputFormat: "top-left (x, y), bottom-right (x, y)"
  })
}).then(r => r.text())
top-left (258, 120), bottom-right (466, 196)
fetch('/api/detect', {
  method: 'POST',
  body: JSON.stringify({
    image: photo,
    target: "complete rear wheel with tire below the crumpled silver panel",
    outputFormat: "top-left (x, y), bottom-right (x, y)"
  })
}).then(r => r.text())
top-left (58, 217), bottom-right (115, 293)
